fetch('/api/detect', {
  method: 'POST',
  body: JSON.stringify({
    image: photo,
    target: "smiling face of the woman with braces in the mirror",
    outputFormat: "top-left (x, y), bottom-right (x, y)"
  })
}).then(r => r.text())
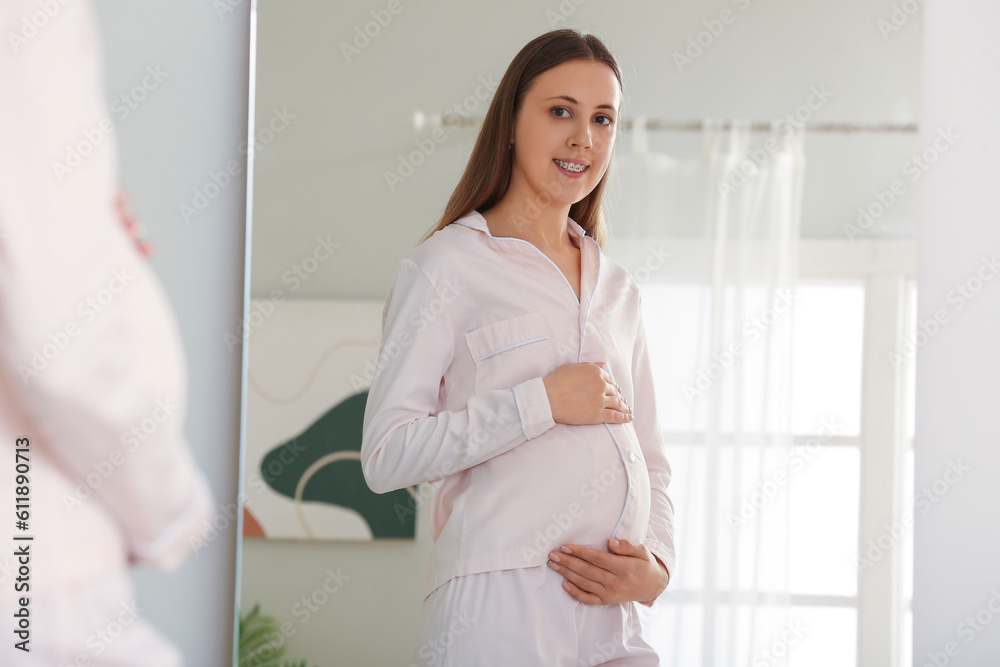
top-left (512, 60), bottom-right (621, 206)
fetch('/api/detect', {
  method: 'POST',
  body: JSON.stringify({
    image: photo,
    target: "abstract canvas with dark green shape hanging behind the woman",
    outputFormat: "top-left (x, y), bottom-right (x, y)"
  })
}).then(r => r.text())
top-left (243, 298), bottom-right (419, 540)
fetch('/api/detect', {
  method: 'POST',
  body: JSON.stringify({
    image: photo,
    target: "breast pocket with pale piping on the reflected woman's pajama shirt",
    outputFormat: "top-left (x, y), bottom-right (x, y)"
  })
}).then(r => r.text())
top-left (465, 312), bottom-right (556, 394)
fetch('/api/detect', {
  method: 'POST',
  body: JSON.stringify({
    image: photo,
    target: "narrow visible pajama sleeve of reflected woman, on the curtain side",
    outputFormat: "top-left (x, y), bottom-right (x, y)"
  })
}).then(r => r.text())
top-left (632, 295), bottom-right (676, 583)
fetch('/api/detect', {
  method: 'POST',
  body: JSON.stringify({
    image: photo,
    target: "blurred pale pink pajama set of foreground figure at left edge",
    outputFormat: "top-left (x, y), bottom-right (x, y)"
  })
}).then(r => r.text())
top-left (0, 0), bottom-right (216, 667)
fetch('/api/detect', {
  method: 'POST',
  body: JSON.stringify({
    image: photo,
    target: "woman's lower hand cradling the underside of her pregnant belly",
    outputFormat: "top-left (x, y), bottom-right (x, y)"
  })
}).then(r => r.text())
top-left (548, 539), bottom-right (670, 606)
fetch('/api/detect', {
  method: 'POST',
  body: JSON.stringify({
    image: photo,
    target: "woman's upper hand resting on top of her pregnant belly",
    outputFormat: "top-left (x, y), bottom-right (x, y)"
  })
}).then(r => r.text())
top-left (543, 361), bottom-right (632, 424)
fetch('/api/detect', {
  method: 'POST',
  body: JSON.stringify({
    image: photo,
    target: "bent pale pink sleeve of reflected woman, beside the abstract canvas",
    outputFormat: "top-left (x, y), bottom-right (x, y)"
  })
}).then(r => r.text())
top-left (361, 258), bottom-right (555, 493)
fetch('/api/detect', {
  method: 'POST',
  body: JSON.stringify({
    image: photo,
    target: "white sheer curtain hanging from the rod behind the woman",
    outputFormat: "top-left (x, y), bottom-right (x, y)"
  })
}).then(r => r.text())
top-left (608, 118), bottom-right (805, 667)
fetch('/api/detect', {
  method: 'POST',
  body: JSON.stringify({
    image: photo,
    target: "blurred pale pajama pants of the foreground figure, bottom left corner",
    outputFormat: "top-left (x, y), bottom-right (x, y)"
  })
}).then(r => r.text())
top-left (0, 570), bottom-right (184, 667)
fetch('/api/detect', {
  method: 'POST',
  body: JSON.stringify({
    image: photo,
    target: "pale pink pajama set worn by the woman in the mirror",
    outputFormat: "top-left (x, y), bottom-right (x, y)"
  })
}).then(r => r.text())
top-left (361, 211), bottom-right (674, 665)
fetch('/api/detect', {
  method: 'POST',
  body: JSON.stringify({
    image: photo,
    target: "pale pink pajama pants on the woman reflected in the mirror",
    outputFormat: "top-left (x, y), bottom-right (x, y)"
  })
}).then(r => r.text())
top-left (411, 565), bottom-right (660, 667)
